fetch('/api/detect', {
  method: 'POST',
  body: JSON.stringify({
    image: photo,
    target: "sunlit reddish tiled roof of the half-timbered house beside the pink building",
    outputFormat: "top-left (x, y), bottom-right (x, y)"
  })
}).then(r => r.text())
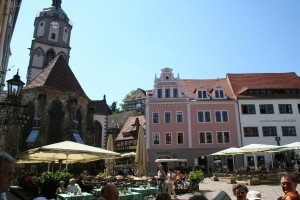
top-left (116, 115), bottom-right (146, 141)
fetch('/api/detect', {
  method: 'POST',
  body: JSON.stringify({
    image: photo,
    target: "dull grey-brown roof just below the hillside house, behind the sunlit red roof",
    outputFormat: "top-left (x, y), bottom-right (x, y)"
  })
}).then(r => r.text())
top-left (107, 110), bottom-right (138, 129)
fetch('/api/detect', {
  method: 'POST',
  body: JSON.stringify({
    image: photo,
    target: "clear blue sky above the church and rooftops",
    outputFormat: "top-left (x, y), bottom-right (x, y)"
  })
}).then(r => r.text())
top-left (7, 0), bottom-right (300, 105)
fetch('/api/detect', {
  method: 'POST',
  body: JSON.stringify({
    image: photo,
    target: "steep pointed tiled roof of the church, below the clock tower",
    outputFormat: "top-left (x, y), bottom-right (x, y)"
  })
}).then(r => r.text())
top-left (24, 55), bottom-right (89, 99)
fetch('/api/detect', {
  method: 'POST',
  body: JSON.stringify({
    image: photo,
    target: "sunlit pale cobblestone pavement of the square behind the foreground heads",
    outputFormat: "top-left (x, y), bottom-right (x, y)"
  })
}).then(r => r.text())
top-left (151, 178), bottom-right (283, 200)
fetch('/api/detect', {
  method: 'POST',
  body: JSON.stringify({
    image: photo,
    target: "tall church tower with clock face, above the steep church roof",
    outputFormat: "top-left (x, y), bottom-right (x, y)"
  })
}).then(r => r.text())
top-left (27, 0), bottom-right (72, 84)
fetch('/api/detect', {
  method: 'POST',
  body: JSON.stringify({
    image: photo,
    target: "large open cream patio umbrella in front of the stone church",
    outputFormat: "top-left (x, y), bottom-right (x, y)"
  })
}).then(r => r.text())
top-left (16, 141), bottom-right (121, 168)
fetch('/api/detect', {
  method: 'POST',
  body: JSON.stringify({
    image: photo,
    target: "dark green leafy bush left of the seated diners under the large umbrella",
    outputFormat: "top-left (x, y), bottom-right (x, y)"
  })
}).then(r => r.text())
top-left (38, 170), bottom-right (73, 198)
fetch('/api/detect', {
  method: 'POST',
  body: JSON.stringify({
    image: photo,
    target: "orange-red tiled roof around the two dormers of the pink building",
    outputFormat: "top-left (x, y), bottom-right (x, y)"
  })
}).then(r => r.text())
top-left (180, 78), bottom-right (235, 100)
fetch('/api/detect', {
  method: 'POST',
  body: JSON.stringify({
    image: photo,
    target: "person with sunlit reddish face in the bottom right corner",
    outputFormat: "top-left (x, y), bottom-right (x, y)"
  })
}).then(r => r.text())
top-left (278, 173), bottom-right (300, 200)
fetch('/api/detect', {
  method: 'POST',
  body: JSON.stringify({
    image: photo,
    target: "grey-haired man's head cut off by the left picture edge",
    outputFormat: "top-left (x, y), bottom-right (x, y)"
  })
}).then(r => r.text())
top-left (0, 151), bottom-right (15, 200)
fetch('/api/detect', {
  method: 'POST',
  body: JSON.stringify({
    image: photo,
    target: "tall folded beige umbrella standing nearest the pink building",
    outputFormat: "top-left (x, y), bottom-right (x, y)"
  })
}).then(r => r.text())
top-left (134, 125), bottom-right (149, 176)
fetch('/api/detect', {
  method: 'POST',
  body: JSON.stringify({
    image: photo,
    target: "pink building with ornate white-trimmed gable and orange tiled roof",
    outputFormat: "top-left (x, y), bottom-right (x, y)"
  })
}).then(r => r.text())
top-left (145, 68), bottom-right (241, 174)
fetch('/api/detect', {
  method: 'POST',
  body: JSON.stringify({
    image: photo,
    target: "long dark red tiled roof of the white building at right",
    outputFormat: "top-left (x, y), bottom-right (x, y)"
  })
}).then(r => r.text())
top-left (227, 72), bottom-right (300, 98)
